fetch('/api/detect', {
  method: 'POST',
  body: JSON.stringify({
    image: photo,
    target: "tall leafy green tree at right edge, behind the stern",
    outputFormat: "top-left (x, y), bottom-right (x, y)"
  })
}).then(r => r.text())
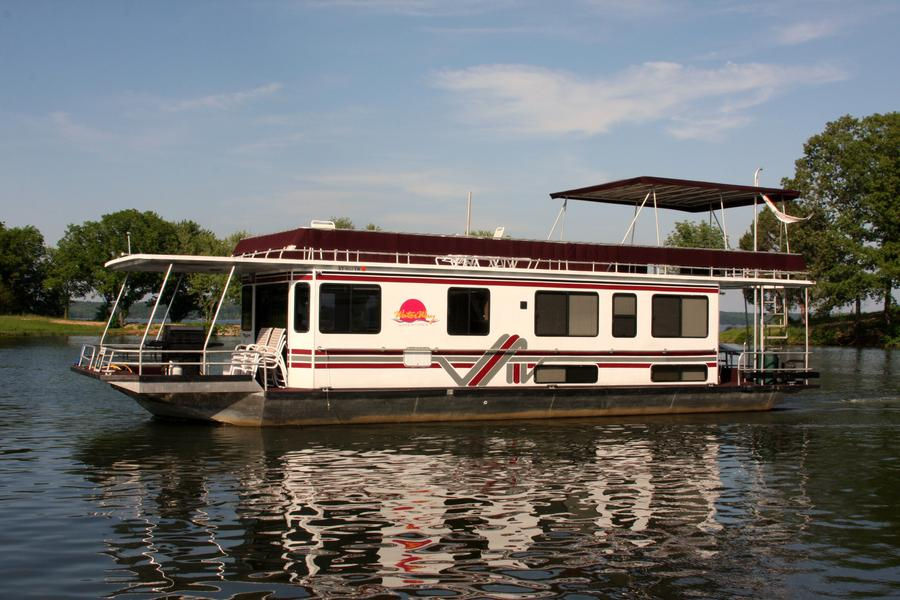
top-left (782, 112), bottom-right (900, 325)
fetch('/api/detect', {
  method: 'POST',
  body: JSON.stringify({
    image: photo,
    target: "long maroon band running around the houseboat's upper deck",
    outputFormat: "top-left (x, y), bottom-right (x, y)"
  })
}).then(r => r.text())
top-left (234, 228), bottom-right (806, 272)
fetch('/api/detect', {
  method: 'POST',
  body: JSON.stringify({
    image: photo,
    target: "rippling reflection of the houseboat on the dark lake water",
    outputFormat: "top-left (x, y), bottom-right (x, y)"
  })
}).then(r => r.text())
top-left (79, 422), bottom-right (804, 596)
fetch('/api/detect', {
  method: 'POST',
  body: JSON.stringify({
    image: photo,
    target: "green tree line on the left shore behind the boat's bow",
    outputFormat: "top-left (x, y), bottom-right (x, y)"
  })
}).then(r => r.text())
top-left (0, 209), bottom-right (247, 325)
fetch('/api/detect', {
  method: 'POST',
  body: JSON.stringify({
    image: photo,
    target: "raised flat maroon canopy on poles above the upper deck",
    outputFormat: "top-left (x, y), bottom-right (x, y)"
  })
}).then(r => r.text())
top-left (550, 176), bottom-right (800, 212)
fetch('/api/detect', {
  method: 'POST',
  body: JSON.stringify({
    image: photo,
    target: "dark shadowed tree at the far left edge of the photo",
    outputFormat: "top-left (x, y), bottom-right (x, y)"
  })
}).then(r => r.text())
top-left (0, 223), bottom-right (59, 314)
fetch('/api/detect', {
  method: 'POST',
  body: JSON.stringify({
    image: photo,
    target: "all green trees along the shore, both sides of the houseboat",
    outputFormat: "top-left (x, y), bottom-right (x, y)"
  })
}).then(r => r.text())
top-left (0, 112), bottom-right (900, 326)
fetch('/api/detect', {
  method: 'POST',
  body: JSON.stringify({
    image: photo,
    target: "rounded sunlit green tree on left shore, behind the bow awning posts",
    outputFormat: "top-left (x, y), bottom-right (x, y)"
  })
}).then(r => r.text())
top-left (54, 209), bottom-right (178, 325)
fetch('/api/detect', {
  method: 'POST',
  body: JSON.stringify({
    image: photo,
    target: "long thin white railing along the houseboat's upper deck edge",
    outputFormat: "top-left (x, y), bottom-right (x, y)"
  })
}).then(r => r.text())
top-left (240, 247), bottom-right (809, 283)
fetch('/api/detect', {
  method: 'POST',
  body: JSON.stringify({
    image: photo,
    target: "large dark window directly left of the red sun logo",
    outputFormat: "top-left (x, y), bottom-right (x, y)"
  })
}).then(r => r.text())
top-left (319, 283), bottom-right (381, 333)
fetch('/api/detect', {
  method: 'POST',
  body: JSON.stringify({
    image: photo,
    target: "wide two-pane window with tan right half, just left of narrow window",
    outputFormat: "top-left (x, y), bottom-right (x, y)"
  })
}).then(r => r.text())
top-left (534, 292), bottom-right (598, 337)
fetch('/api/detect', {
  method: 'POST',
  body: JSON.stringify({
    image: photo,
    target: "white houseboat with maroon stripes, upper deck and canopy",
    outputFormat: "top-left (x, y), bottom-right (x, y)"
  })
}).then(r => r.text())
top-left (73, 177), bottom-right (817, 426)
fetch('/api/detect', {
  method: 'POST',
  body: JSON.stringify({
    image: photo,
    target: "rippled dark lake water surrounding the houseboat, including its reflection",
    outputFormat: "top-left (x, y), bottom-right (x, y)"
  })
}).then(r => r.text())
top-left (0, 338), bottom-right (900, 599)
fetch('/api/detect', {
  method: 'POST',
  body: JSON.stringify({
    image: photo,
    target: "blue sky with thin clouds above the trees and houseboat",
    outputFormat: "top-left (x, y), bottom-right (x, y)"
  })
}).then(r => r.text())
top-left (0, 0), bottom-right (900, 245)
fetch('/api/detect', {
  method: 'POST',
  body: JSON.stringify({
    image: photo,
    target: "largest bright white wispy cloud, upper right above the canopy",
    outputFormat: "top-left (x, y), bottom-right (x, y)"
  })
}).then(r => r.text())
top-left (435, 62), bottom-right (846, 136)
